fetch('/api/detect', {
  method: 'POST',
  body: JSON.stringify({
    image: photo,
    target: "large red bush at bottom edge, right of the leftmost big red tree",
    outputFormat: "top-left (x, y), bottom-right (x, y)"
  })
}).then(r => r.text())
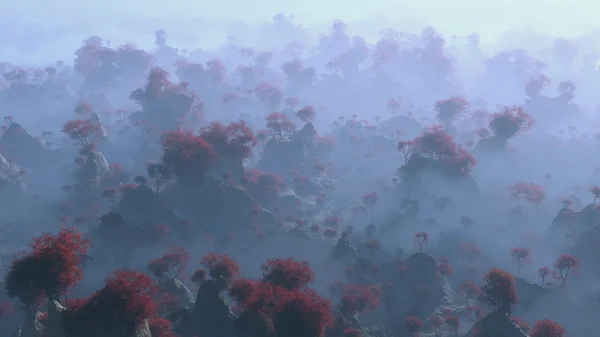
top-left (65, 270), bottom-right (156, 336)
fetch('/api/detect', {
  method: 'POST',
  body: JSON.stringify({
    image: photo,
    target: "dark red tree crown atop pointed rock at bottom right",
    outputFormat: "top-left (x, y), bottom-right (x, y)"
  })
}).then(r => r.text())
top-left (481, 268), bottom-right (518, 315)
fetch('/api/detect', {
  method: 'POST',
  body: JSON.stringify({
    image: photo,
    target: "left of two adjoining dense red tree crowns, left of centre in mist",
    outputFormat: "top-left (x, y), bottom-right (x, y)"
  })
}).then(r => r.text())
top-left (163, 130), bottom-right (216, 184)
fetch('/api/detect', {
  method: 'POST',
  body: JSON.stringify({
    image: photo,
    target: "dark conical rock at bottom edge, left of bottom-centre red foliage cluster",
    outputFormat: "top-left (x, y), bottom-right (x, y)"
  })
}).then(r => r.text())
top-left (183, 280), bottom-right (237, 337)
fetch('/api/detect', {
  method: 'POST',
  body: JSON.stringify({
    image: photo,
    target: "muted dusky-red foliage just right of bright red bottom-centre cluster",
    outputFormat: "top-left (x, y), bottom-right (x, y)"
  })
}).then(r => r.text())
top-left (341, 284), bottom-right (381, 315)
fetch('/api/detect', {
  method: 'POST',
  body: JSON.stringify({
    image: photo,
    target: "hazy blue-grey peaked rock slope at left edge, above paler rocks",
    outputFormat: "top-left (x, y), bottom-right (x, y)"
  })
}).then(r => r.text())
top-left (0, 123), bottom-right (59, 169)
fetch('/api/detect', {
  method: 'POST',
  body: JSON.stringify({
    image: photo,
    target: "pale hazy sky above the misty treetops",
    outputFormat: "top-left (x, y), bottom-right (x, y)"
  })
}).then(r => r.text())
top-left (0, 0), bottom-right (600, 63)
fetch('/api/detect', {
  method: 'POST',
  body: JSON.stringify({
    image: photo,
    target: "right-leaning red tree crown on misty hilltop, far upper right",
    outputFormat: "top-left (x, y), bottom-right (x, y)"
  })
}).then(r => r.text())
top-left (490, 106), bottom-right (535, 139)
